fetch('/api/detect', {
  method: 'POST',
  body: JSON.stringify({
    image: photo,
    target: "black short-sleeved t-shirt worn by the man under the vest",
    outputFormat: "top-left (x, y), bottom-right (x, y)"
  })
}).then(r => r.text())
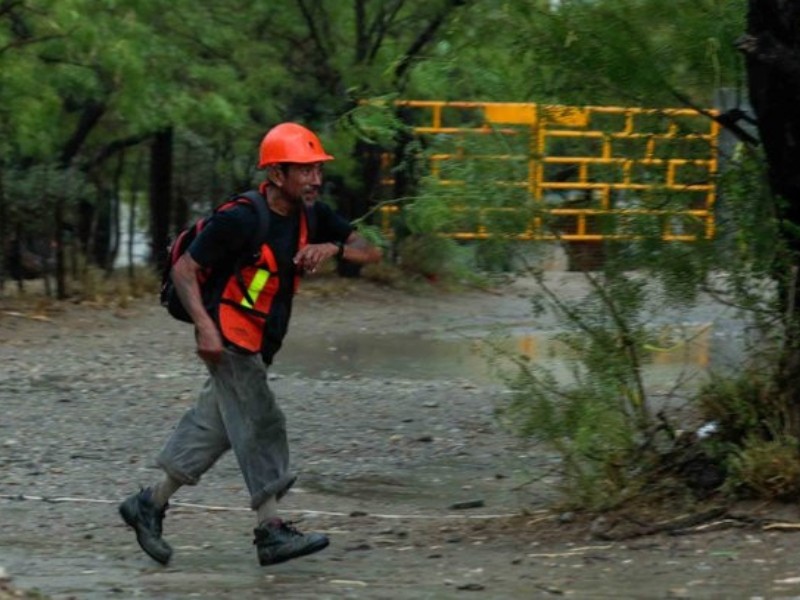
top-left (188, 202), bottom-right (353, 364)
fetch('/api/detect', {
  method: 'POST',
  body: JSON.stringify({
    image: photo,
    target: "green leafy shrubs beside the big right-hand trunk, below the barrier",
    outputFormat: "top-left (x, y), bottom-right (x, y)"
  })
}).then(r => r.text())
top-left (494, 138), bottom-right (800, 509)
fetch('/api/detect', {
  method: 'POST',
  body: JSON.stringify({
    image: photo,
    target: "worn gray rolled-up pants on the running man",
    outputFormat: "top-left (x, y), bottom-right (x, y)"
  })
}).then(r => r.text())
top-left (156, 350), bottom-right (296, 509)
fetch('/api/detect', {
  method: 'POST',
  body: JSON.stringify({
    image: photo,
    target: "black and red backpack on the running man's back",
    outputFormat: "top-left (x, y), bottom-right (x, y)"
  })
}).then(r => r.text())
top-left (160, 190), bottom-right (270, 323)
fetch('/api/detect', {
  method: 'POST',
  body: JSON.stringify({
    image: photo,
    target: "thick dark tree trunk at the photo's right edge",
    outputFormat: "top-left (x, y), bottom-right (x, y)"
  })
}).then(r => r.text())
top-left (738, 0), bottom-right (800, 438)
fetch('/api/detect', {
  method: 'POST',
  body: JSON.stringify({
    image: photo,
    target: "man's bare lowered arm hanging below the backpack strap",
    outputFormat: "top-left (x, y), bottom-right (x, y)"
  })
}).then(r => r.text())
top-left (170, 252), bottom-right (222, 364)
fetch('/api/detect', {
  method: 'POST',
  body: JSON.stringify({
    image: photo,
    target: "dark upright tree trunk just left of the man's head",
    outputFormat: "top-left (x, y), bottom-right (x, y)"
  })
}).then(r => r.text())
top-left (150, 127), bottom-right (173, 271)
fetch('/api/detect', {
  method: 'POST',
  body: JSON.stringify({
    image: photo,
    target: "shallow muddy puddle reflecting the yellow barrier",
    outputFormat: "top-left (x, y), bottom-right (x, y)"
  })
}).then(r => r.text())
top-left (276, 323), bottom-right (740, 386)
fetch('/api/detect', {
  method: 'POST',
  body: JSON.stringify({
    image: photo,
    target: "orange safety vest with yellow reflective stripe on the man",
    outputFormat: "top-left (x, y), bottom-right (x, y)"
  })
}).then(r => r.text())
top-left (218, 210), bottom-right (308, 353)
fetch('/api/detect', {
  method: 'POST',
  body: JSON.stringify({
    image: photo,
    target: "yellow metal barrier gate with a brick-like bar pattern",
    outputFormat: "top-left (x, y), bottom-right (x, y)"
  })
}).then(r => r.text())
top-left (381, 100), bottom-right (719, 241)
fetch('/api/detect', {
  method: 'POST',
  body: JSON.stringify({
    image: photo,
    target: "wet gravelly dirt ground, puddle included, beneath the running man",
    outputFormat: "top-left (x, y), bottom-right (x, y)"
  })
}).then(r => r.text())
top-left (0, 274), bottom-right (800, 600)
